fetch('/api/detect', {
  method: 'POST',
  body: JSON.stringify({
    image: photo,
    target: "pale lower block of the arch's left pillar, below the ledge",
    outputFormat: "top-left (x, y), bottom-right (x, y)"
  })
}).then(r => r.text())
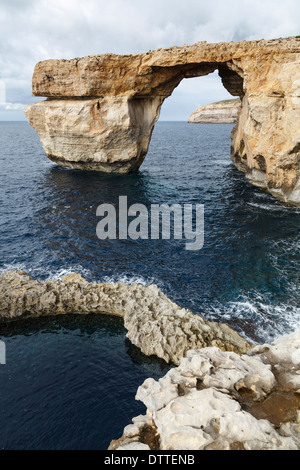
top-left (26, 96), bottom-right (162, 173)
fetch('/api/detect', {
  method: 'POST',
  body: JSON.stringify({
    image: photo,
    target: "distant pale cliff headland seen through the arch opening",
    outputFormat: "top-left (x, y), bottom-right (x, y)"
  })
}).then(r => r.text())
top-left (188, 99), bottom-right (241, 124)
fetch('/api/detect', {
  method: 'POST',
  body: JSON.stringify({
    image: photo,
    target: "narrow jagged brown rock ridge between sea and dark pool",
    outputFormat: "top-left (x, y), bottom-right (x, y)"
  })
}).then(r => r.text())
top-left (0, 271), bottom-right (250, 364)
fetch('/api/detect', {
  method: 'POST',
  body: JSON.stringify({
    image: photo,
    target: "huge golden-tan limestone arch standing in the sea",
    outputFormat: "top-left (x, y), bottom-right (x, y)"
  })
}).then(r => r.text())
top-left (25, 38), bottom-right (300, 205)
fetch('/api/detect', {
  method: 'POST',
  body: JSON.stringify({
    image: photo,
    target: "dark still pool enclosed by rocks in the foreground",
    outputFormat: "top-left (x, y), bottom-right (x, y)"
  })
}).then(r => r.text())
top-left (0, 315), bottom-right (168, 450)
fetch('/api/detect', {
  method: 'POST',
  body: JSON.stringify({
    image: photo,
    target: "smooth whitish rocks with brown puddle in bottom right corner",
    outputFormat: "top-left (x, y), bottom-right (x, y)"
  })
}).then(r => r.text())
top-left (110, 331), bottom-right (300, 450)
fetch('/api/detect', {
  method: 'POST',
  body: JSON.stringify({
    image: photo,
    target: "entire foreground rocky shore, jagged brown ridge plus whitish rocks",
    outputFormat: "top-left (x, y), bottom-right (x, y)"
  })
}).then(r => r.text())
top-left (0, 271), bottom-right (300, 450)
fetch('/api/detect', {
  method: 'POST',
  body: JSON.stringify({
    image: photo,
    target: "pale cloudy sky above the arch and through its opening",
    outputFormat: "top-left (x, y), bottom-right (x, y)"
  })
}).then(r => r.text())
top-left (0, 0), bottom-right (300, 121)
